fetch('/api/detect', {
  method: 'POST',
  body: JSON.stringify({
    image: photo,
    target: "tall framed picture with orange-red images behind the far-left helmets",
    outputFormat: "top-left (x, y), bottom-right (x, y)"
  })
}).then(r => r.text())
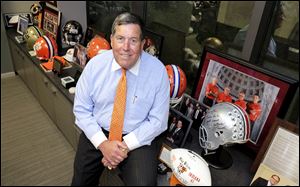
top-left (42, 6), bottom-right (61, 41)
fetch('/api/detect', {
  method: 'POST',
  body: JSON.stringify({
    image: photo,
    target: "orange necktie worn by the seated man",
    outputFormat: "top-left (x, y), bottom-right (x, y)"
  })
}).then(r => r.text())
top-left (108, 68), bottom-right (126, 141)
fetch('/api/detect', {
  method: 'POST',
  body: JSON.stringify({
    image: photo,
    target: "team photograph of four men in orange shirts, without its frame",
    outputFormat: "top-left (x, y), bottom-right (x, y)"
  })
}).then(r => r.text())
top-left (198, 60), bottom-right (279, 143)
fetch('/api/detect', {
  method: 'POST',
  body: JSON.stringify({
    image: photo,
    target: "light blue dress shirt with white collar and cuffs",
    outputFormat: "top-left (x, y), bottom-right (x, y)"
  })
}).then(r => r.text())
top-left (73, 50), bottom-right (170, 150)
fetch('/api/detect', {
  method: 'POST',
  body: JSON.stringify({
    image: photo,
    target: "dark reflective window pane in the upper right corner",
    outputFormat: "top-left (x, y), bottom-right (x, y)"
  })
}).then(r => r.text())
top-left (262, 1), bottom-right (299, 80)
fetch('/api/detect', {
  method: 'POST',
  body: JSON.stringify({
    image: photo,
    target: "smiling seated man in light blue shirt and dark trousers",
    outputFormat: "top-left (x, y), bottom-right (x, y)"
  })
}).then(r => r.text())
top-left (72, 13), bottom-right (170, 186)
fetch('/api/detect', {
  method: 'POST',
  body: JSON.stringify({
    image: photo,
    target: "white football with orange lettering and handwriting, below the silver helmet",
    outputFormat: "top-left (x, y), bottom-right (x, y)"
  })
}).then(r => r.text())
top-left (170, 148), bottom-right (211, 186)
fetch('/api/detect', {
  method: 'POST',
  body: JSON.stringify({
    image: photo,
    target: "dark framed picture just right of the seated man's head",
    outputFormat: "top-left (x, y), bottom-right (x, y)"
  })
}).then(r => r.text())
top-left (144, 28), bottom-right (163, 59)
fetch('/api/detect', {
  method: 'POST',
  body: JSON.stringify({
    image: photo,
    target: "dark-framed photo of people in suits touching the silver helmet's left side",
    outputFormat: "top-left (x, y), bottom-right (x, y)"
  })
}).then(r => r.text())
top-left (175, 93), bottom-right (209, 130)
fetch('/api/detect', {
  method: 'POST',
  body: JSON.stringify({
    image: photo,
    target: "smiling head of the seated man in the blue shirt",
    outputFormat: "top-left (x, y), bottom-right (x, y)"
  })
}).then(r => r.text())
top-left (110, 12), bottom-right (145, 69)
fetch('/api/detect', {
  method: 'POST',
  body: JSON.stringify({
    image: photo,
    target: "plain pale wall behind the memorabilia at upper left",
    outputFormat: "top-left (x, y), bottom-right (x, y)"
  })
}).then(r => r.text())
top-left (1, 1), bottom-right (87, 74)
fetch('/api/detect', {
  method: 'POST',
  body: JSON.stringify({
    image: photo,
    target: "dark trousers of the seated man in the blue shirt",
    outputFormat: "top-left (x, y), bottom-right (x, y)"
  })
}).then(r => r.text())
top-left (72, 133), bottom-right (159, 186)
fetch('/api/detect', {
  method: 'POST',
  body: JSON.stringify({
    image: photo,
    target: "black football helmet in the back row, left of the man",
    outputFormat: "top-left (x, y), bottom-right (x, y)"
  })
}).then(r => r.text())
top-left (62, 20), bottom-right (83, 46)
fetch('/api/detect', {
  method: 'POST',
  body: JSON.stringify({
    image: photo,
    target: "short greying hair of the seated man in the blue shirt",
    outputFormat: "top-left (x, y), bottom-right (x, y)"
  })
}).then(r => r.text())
top-left (111, 12), bottom-right (144, 40)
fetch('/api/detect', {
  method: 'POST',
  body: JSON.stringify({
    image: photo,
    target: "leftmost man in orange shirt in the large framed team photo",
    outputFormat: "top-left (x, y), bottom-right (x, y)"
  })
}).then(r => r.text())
top-left (203, 77), bottom-right (219, 107)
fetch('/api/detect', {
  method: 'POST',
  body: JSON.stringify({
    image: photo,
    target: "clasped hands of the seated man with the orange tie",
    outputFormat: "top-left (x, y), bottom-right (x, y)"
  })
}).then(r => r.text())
top-left (98, 140), bottom-right (128, 168)
